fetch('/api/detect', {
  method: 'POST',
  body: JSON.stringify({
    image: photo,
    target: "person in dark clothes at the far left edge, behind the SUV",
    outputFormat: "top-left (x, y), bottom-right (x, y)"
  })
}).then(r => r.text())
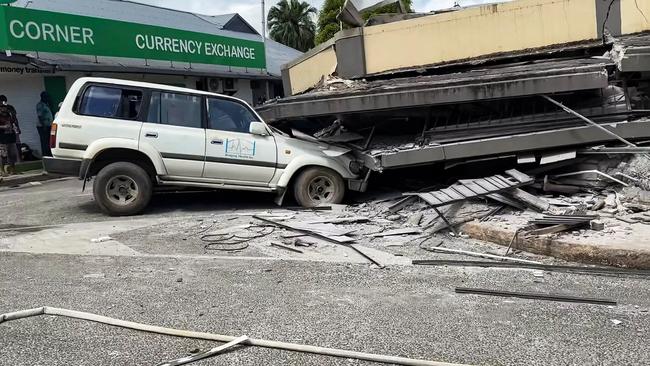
top-left (0, 95), bottom-right (20, 175)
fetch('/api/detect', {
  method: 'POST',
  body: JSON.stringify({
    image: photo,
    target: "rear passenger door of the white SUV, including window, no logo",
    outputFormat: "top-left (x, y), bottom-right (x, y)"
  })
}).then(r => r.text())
top-left (140, 90), bottom-right (205, 177)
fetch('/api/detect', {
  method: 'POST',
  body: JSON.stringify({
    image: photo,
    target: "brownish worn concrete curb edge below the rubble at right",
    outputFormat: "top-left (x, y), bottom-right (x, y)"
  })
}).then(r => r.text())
top-left (461, 221), bottom-right (650, 269)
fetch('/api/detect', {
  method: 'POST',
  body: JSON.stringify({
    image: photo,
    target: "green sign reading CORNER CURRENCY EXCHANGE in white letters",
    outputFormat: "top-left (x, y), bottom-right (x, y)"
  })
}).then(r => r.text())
top-left (0, 6), bottom-right (266, 69)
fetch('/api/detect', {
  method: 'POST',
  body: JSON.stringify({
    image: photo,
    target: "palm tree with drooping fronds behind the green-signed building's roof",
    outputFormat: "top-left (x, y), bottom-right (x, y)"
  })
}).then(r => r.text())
top-left (267, 0), bottom-right (317, 52)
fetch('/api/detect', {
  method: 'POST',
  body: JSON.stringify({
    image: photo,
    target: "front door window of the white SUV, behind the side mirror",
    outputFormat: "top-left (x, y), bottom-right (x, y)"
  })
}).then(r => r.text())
top-left (208, 98), bottom-right (258, 133)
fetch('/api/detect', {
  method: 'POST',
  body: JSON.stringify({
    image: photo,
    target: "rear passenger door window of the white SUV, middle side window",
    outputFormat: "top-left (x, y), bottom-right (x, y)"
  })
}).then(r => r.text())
top-left (147, 91), bottom-right (203, 128)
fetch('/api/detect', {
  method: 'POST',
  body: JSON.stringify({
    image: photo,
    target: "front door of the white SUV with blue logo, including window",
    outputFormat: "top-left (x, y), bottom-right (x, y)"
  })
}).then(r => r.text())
top-left (203, 97), bottom-right (277, 185)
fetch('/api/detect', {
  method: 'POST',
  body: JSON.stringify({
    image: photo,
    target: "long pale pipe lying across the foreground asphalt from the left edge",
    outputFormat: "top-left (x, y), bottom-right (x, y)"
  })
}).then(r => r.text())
top-left (0, 306), bottom-right (467, 366)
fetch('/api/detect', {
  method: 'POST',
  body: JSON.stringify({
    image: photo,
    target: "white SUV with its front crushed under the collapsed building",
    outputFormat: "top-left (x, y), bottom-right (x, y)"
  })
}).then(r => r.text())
top-left (43, 78), bottom-right (363, 215)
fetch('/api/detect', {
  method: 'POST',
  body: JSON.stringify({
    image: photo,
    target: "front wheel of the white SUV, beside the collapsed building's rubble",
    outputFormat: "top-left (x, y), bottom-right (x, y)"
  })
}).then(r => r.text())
top-left (293, 167), bottom-right (345, 207)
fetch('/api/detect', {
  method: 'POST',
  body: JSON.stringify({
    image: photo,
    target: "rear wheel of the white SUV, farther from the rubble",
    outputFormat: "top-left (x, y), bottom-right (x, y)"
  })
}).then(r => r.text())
top-left (93, 162), bottom-right (153, 216)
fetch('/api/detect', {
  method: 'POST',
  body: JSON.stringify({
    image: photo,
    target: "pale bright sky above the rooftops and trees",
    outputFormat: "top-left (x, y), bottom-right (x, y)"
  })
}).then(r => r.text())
top-left (133, 0), bottom-right (504, 33)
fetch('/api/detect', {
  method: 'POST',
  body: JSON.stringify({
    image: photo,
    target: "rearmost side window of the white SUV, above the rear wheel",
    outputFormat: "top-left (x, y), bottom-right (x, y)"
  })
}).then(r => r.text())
top-left (78, 85), bottom-right (142, 120)
